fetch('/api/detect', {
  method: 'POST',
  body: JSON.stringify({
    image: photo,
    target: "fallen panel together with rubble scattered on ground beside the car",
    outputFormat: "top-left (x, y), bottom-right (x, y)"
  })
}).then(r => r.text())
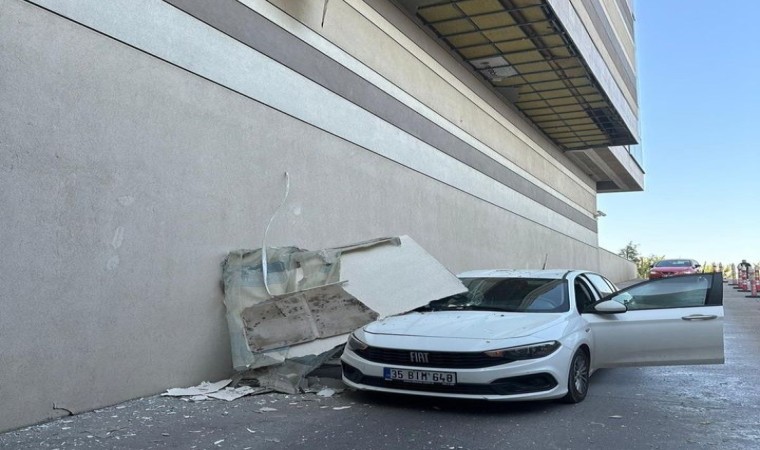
top-left (161, 236), bottom-right (466, 402)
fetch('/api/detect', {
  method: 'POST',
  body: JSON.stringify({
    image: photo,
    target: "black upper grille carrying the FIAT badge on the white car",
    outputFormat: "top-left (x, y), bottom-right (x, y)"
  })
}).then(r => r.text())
top-left (354, 347), bottom-right (514, 369)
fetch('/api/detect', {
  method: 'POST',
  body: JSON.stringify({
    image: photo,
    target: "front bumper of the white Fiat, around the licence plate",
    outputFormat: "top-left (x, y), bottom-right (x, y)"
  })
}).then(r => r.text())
top-left (341, 347), bottom-right (572, 401)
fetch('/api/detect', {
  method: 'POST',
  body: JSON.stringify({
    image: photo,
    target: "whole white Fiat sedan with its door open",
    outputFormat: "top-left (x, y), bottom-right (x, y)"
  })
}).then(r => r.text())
top-left (341, 270), bottom-right (724, 403)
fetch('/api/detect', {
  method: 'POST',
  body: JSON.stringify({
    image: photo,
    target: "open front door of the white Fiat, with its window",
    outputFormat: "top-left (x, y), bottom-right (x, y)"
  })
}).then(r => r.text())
top-left (583, 273), bottom-right (724, 368)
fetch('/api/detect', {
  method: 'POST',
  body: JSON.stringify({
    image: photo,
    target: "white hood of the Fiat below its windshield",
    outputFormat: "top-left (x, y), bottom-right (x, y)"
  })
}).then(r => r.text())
top-left (364, 311), bottom-right (564, 339)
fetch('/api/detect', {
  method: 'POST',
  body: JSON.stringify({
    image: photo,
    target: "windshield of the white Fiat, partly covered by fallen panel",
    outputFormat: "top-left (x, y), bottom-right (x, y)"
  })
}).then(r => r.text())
top-left (429, 278), bottom-right (570, 312)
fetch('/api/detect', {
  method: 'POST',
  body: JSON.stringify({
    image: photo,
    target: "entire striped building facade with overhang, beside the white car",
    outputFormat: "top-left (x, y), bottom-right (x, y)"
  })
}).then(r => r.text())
top-left (0, 0), bottom-right (643, 430)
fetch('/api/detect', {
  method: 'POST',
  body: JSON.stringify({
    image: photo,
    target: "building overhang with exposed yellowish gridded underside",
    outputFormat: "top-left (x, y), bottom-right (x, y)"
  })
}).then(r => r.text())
top-left (396, 0), bottom-right (643, 191)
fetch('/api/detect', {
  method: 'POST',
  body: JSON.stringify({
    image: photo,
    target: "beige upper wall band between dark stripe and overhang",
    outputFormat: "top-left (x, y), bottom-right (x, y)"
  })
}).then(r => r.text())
top-left (266, 0), bottom-right (596, 213)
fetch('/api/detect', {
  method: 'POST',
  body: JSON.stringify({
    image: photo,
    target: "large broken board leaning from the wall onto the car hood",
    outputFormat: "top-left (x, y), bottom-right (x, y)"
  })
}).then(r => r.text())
top-left (223, 236), bottom-right (467, 371)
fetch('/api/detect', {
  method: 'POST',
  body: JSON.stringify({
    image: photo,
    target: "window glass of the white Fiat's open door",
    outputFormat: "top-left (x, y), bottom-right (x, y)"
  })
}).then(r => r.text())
top-left (610, 274), bottom-right (722, 311)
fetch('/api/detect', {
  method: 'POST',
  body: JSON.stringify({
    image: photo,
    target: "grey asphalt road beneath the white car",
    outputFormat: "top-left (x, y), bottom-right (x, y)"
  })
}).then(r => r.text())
top-left (0, 287), bottom-right (760, 450)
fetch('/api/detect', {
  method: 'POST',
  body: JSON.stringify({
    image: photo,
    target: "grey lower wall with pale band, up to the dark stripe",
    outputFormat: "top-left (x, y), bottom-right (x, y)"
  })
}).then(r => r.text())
top-left (0, 0), bottom-right (612, 430)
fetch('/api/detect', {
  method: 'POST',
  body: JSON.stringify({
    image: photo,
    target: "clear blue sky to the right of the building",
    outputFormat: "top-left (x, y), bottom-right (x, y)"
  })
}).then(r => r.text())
top-left (598, 0), bottom-right (760, 264)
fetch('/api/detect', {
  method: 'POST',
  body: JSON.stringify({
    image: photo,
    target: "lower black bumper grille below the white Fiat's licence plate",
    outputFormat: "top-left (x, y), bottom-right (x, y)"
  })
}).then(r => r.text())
top-left (343, 362), bottom-right (557, 395)
